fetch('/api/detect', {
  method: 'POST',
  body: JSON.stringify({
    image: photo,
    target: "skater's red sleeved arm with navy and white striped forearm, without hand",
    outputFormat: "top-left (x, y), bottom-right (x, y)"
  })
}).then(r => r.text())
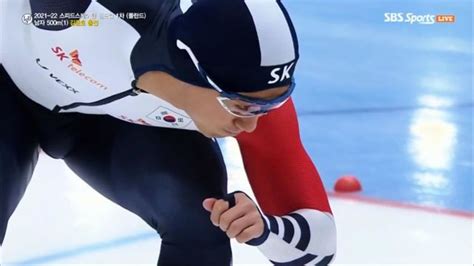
top-left (237, 100), bottom-right (336, 265)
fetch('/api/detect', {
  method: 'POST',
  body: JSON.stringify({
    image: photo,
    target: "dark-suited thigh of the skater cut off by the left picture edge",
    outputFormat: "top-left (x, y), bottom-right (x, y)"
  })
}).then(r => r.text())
top-left (0, 65), bottom-right (38, 241)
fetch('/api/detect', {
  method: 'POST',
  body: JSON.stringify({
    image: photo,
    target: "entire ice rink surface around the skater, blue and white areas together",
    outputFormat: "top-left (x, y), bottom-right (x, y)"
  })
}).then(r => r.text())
top-left (2, 0), bottom-right (474, 265)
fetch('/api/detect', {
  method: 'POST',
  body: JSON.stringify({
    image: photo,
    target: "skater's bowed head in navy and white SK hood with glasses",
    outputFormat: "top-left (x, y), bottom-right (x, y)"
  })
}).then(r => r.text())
top-left (169, 0), bottom-right (299, 117)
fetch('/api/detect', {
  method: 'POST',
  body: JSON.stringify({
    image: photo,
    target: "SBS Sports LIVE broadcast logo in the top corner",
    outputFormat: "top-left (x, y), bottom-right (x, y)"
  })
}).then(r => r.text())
top-left (384, 12), bottom-right (456, 25)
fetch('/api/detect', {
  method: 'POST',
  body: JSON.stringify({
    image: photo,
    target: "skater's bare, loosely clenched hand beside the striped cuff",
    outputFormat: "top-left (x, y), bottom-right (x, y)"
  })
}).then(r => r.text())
top-left (202, 193), bottom-right (264, 243)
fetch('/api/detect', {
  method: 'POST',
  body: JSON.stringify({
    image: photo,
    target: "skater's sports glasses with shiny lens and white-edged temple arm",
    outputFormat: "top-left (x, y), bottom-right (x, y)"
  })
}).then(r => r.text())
top-left (177, 40), bottom-right (295, 118)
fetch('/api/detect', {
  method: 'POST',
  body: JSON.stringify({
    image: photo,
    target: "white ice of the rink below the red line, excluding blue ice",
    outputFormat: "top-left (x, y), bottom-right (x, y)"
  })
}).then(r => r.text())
top-left (2, 150), bottom-right (473, 266)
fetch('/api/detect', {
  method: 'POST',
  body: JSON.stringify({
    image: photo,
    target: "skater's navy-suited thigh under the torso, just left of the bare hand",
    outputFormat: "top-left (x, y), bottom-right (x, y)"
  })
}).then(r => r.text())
top-left (65, 117), bottom-right (227, 226)
